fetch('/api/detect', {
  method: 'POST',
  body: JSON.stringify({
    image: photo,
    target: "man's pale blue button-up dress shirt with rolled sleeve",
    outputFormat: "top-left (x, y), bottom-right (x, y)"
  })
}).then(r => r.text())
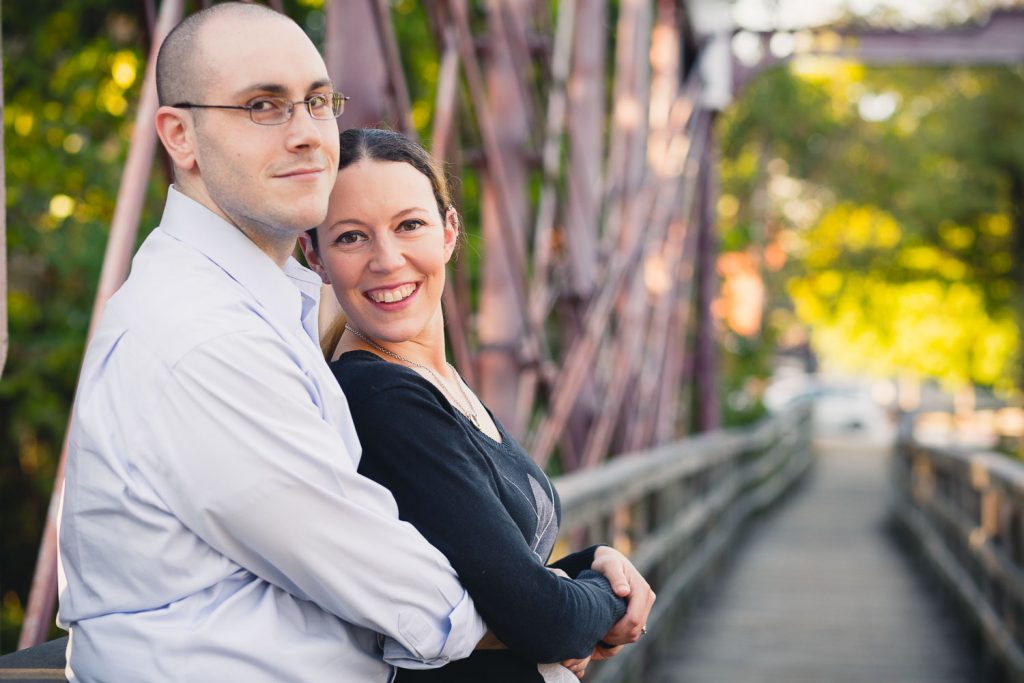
top-left (58, 187), bottom-right (485, 683)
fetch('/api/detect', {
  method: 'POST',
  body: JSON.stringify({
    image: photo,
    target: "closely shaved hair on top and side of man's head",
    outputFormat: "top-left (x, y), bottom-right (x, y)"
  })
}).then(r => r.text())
top-left (157, 2), bottom-right (294, 106)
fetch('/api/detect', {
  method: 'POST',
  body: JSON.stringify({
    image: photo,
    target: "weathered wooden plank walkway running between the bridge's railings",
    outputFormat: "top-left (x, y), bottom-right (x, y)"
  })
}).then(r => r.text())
top-left (645, 432), bottom-right (984, 683)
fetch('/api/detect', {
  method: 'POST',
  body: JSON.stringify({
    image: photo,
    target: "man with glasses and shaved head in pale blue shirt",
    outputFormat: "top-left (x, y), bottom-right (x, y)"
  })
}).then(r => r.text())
top-left (58, 3), bottom-right (649, 682)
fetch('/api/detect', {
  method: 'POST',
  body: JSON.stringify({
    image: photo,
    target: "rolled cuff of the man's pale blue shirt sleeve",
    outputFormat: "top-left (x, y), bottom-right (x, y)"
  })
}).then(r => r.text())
top-left (384, 591), bottom-right (487, 669)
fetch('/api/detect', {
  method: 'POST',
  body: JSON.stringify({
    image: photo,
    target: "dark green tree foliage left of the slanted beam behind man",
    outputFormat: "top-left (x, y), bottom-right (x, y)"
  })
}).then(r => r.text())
top-left (0, 0), bottom-right (158, 650)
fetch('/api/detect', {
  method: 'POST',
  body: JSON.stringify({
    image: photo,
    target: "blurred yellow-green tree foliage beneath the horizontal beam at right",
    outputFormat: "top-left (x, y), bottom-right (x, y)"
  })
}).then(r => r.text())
top-left (721, 58), bottom-right (1024, 390)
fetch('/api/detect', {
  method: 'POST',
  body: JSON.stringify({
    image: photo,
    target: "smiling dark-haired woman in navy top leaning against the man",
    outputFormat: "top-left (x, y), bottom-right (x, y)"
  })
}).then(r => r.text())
top-left (302, 129), bottom-right (653, 682)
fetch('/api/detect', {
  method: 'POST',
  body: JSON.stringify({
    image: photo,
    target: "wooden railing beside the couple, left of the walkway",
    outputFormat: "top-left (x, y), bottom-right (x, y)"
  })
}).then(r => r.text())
top-left (556, 404), bottom-right (813, 683)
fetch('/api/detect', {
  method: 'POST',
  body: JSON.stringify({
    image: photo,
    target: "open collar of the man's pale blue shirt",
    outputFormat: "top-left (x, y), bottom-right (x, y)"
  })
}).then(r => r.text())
top-left (160, 185), bottom-right (321, 342)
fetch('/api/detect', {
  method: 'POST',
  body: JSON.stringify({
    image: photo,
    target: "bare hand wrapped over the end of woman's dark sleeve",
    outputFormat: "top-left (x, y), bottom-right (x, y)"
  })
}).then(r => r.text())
top-left (590, 546), bottom-right (656, 647)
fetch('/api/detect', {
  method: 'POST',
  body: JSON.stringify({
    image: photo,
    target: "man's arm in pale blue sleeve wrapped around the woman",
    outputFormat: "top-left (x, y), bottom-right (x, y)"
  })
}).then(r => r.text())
top-left (135, 330), bottom-right (485, 666)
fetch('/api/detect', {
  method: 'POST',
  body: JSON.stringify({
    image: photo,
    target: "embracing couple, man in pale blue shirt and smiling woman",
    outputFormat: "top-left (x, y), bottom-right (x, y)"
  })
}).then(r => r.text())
top-left (58, 3), bottom-right (654, 682)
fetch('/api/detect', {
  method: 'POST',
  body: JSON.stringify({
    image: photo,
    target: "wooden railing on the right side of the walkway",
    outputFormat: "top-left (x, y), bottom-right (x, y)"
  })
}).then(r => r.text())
top-left (893, 430), bottom-right (1024, 681)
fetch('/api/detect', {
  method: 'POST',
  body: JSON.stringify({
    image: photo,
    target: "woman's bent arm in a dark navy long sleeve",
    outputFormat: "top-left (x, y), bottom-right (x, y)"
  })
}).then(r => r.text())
top-left (343, 368), bottom-right (625, 661)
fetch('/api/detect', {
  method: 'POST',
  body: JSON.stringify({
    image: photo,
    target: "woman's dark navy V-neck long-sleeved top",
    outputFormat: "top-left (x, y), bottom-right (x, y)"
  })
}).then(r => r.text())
top-left (331, 351), bottom-right (626, 683)
